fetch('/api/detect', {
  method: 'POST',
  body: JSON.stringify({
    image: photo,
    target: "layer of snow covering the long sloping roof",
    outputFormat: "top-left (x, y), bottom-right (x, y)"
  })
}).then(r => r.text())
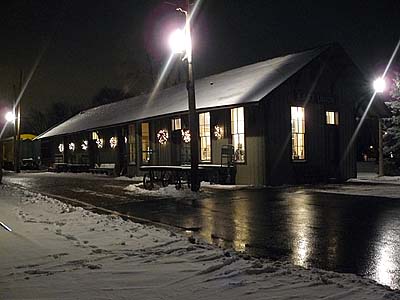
top-left (37, 47), bottom-right (327, 139)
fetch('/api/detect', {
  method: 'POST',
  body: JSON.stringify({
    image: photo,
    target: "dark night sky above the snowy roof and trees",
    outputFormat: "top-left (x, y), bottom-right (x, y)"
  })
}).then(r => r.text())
top-left (0, 0), bottom-right (400, 120)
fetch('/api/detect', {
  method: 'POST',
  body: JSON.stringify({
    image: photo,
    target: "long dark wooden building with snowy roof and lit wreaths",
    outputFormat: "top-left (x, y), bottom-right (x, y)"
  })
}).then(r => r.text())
top-left (38, 44), bottom-right (385, 185)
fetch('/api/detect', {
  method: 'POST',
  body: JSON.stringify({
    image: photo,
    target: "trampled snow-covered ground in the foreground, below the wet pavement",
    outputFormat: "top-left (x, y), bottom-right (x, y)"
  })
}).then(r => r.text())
top-left (0, 185), bottom-right (400, 299)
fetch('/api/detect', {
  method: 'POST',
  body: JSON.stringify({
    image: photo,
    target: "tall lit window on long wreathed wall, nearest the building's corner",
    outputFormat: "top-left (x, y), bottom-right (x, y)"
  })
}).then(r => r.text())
top-left (231, 107), bottom-right (245, 162)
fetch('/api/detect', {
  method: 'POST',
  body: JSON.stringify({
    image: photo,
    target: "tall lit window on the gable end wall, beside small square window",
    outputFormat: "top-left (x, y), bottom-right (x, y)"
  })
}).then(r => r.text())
top-left (291, 106), bottom-right (306, 160)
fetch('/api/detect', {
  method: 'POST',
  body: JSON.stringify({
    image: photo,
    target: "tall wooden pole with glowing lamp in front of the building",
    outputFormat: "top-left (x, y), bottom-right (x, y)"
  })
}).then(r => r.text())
top-left (169, 1), bottom-right (200, 192)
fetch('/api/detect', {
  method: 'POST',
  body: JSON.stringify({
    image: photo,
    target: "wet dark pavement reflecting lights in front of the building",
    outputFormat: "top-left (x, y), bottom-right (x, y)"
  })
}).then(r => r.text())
top-left (4, 173), bottom-right (400, 288)
